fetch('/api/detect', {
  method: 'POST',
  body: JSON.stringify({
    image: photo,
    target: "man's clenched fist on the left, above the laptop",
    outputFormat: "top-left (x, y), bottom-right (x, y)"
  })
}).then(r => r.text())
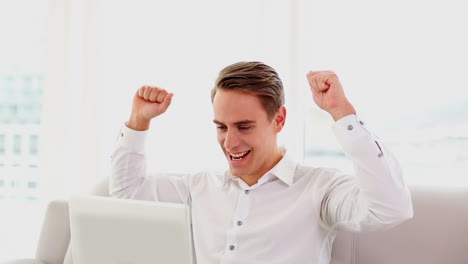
top-left (127, 86), bottom-right (174, 131)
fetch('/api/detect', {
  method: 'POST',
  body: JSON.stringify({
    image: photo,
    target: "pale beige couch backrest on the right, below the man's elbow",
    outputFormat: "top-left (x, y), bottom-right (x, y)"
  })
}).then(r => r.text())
top-left (331, 186), bottom-right (468, 264)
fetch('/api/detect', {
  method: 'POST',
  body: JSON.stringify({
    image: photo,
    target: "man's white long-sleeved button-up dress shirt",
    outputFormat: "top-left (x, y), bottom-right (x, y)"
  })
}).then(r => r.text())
top-left (110, 115), bottom-right (413, 264)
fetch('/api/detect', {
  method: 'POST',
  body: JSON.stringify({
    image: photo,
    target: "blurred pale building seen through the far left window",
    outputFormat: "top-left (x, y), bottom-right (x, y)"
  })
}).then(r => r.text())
top-left (0, 74), bottom-right (43, 200)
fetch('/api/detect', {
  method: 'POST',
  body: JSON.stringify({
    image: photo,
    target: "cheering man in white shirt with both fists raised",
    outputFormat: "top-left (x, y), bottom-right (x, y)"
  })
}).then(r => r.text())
top-left (110, 62), bottom-right (412, 264)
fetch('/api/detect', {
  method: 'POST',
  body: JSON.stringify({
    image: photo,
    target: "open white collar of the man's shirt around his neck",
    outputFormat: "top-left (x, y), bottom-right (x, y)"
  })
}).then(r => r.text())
top-left (224, 148), bottom-right (296, 186)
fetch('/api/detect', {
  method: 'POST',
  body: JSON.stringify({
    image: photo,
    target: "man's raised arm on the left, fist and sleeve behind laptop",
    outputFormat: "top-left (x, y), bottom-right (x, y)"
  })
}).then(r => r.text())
top-left (109, 86), bottom-right (188, 202)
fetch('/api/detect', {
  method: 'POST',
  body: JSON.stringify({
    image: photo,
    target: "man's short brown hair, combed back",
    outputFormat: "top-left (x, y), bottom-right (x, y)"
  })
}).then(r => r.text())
top-left (211, 61), bottom-right (284, 120)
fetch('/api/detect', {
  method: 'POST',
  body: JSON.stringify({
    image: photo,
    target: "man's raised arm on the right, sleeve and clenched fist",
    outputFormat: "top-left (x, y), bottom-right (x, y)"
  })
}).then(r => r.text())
top-left (307, 71), bottom-right (412, 231)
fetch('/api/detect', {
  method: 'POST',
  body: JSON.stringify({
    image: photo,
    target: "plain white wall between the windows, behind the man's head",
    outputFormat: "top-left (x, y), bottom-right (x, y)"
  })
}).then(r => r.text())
top-left (44, 0), bottom-right (302, 198)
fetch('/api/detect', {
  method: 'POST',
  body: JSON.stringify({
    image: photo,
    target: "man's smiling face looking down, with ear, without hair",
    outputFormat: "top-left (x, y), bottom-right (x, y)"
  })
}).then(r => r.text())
top-left (213, 89), bottom-right (286, 182)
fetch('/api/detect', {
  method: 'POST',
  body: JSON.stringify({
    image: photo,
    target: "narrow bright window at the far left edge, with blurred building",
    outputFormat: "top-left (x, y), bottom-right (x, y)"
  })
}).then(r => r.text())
top-left (0, 0), bottom-right (48, 262)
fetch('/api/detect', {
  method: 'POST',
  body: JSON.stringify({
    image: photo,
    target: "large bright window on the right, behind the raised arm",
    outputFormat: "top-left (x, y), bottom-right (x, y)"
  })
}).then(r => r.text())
top-left (300, 0), bottom-right (468, 186)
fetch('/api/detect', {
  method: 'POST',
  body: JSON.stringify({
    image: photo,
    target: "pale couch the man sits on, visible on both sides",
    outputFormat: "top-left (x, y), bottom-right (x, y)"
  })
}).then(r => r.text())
top-left (1, 179), bottom-right (468, 264)
